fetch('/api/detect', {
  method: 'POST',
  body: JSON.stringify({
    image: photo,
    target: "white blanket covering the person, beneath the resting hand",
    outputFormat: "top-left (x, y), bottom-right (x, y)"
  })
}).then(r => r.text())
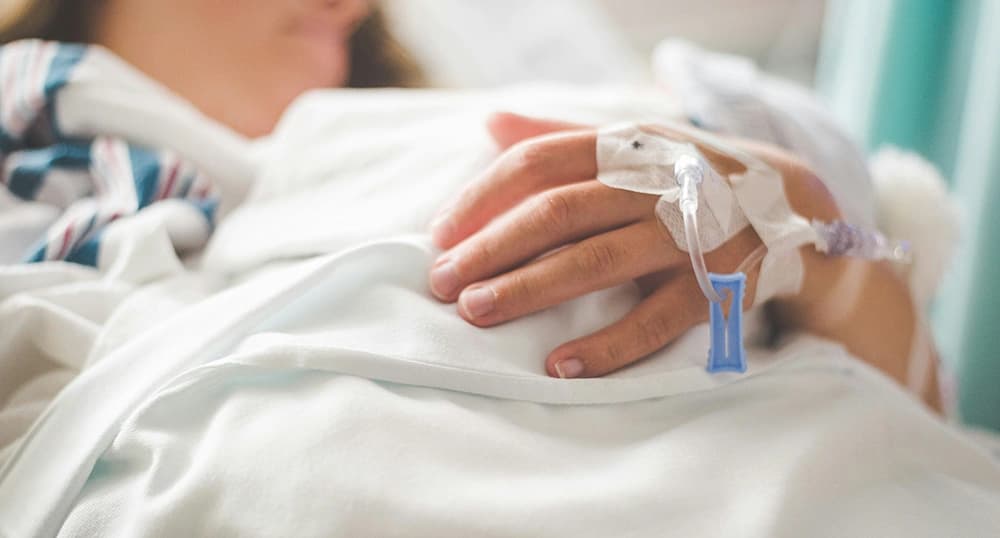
top-left (0, 88), bottom-right (1000, 537)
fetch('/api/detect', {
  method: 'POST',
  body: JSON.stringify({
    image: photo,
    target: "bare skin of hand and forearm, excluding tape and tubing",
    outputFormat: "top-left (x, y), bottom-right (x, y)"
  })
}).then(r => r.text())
top-left (429, 114), bottom-right (940, 409)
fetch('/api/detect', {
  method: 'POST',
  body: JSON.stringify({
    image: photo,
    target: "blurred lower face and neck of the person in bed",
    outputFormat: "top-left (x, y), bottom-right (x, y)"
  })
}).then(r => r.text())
top-left (95, 0), bottom-right (370, 136)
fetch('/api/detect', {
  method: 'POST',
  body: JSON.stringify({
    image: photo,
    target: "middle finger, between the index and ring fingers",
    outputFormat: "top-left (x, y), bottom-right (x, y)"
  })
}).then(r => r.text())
top-left (430, 180), bottom-right (656, 301)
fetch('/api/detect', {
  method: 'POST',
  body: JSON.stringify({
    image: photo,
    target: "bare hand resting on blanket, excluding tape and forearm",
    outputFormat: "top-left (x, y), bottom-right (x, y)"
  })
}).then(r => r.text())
top-left (430, 114), bottom-right (836, 377)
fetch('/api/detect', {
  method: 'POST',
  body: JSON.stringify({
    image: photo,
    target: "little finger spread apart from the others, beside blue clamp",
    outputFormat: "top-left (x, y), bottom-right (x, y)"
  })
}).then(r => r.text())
top-left (545, 273), bottom-right (708, 378)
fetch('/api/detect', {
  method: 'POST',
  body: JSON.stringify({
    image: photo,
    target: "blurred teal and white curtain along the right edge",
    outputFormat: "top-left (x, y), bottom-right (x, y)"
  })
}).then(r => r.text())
top-left (816, 0), bottom-right (1000, 430)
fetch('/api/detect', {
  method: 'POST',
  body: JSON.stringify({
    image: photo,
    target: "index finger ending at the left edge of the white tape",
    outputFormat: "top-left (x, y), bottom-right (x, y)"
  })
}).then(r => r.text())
top-left (431, 130), bottom-right (597, 249)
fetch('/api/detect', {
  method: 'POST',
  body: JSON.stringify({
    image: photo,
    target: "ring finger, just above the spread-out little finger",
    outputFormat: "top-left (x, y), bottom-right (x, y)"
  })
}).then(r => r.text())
top-left (450, 220), bottom-right (683, 327)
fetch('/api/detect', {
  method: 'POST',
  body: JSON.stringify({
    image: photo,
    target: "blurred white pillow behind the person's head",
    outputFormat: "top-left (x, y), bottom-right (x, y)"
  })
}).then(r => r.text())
top-left (383, 0), bottom-right (648, 87)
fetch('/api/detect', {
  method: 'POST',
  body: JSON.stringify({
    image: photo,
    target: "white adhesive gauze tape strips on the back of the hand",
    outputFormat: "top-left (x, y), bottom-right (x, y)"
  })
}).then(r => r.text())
top-left (597, 123), bottom-right (818, 303)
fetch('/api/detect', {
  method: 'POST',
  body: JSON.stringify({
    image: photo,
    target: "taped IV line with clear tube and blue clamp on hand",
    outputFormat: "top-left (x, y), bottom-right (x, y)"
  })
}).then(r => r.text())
top-left (597, 123), bottom-right (916, 373)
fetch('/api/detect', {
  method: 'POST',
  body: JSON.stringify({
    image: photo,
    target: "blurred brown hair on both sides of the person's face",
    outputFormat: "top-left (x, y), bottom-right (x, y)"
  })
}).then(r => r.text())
top-left (0, 0), bottom-right (424, 88)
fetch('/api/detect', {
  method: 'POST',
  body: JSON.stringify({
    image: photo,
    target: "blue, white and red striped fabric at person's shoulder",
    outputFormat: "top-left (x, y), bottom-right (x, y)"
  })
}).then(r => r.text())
top-left (0, 40), bottom-right (218, 266)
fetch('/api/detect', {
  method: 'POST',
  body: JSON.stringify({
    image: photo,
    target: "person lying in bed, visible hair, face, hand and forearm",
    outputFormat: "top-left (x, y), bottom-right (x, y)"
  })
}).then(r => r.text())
top-left (2, 0), bottom-right (941, 409)
